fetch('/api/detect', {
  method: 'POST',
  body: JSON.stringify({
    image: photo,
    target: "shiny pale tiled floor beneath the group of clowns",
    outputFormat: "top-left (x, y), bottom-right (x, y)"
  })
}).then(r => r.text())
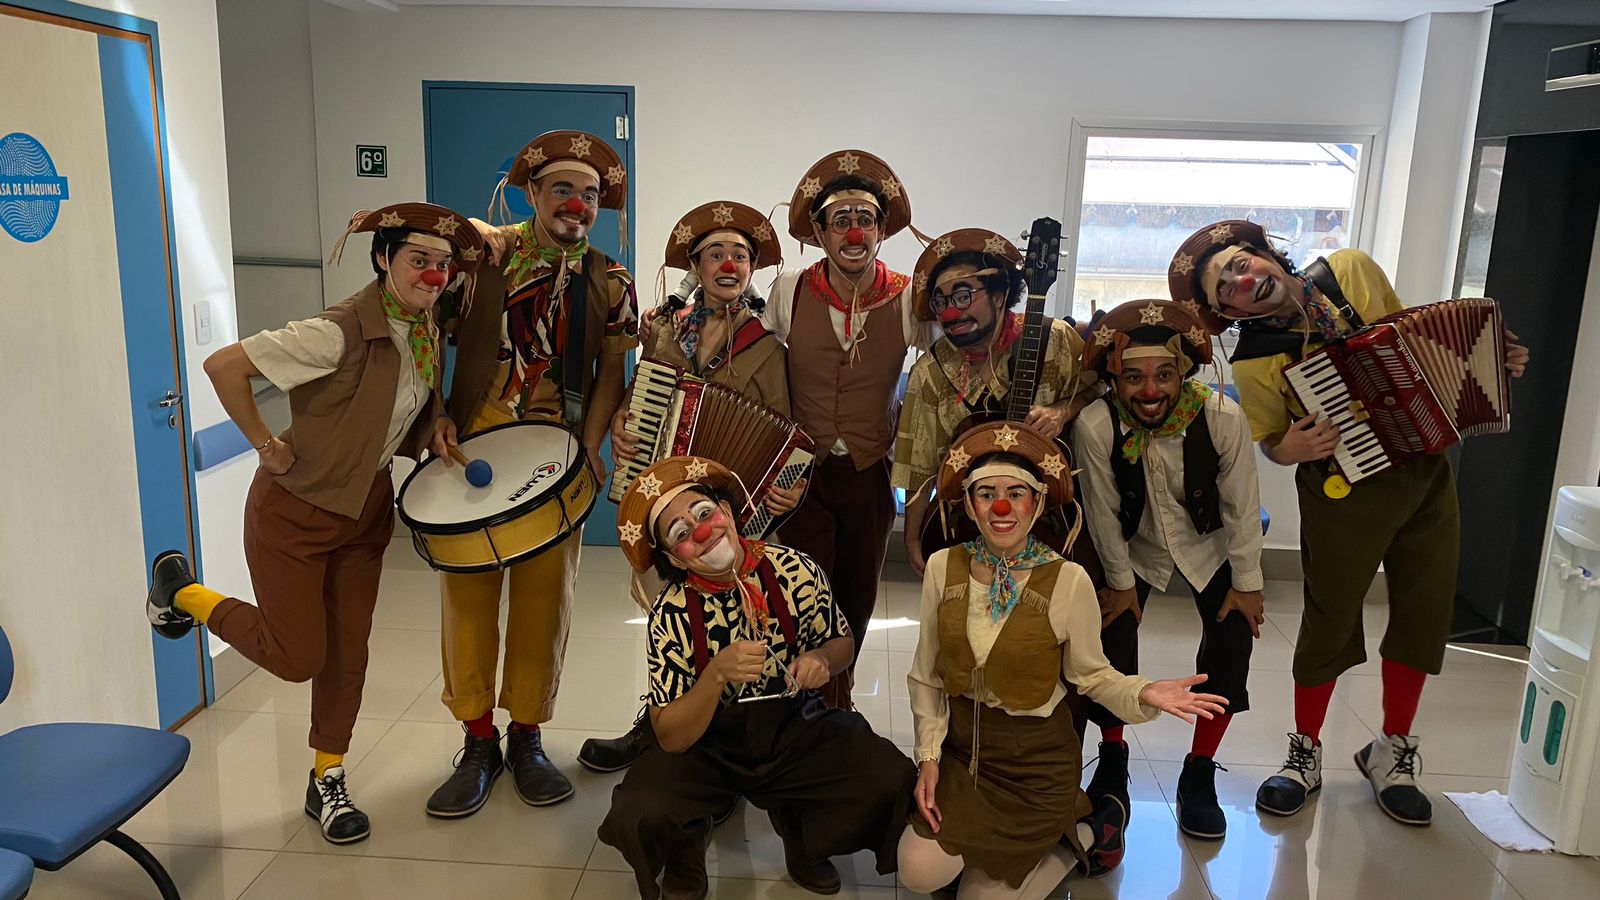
top-left (30, 543), bottom-right (1600, 900)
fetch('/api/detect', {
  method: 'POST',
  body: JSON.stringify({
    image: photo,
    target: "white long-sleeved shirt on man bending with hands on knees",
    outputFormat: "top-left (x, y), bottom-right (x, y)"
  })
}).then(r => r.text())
top-left (1072, 391), bottom-right (1262, 591)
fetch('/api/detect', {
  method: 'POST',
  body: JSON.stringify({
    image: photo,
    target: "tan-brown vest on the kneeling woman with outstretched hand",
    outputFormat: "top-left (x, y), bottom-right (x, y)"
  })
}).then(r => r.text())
top-left (939, 544), bottom-right (1062, 709)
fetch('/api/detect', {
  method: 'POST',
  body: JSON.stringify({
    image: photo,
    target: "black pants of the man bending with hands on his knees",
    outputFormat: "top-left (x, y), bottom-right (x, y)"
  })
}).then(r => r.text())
top-left (1090, 562), bottom-right (1254, 729)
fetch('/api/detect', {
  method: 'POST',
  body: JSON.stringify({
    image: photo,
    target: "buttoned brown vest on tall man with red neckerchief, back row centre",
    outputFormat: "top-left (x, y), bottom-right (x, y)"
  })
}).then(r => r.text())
top-left (778, 277), bottom-right (906, 472)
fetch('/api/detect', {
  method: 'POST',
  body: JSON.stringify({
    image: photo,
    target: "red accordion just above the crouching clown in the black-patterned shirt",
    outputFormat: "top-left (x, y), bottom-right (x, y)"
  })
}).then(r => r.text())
top-left (611, 359), bottom-right (816, 538)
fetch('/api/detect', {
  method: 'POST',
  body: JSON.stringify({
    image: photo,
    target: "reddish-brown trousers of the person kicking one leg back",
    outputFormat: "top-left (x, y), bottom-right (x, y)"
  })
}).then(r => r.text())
top-left (206, 466), bottom-right (395, 753)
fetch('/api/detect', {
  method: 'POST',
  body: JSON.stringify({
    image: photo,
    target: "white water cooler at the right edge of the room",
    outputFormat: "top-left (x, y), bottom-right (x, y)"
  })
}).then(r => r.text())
top-left (1510, 487), bottom-right (1600, 855)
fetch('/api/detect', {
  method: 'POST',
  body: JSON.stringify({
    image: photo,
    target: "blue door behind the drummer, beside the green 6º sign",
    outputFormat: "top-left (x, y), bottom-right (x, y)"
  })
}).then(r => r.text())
top-left (422, 82), bottom-right (637, 546)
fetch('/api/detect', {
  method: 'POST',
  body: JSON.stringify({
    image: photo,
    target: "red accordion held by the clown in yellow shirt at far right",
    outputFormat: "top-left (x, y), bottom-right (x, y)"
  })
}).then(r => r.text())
top-left (1283, 299), bottom-right (1510, 484)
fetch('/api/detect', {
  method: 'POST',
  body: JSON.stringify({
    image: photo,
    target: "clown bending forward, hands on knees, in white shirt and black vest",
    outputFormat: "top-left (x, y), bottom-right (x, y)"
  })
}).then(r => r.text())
top-left (1072, 299), bottom-right (1266, 839)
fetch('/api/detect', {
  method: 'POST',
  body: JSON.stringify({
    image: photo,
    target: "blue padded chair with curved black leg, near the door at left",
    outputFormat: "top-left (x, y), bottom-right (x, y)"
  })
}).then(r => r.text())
top-left (0, 629), bottom-right (189, 900)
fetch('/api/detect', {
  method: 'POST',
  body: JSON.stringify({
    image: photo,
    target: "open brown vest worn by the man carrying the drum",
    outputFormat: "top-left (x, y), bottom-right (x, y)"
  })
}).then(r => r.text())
top-left (450, 247), bottom-right (624, 434)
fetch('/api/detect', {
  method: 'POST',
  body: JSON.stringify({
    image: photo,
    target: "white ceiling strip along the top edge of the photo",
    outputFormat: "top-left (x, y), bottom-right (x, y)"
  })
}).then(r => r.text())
top-left (366, 0), bottom-right (1494, 22)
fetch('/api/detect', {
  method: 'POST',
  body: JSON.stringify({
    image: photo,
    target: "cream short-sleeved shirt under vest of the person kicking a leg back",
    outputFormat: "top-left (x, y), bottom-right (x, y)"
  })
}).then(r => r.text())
top-left (238, 317), bottom-right (443, 469)
